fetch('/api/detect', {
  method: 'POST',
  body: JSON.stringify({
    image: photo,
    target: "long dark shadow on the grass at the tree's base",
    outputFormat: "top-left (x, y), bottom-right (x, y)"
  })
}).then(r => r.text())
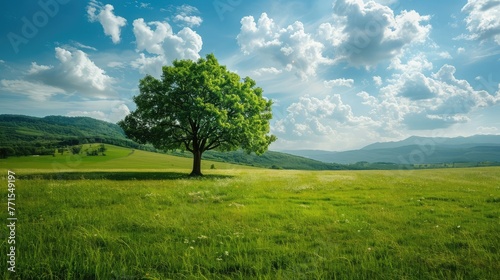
top-left (18, 171), bottom-right (233, 181)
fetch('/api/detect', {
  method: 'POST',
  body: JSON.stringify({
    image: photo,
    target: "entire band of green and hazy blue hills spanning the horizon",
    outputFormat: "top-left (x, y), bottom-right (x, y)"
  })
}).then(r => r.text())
top-left (0, 115), bottom-right (500, 170)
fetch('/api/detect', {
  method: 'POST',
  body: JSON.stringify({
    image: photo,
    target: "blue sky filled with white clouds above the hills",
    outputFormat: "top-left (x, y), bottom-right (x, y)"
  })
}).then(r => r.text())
top-left (0, 0), bottom-right (500, 151)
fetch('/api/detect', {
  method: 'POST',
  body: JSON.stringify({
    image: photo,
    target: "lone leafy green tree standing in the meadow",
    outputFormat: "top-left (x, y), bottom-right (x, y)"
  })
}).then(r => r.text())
top-left (118, 54), bottom-right (276, 176)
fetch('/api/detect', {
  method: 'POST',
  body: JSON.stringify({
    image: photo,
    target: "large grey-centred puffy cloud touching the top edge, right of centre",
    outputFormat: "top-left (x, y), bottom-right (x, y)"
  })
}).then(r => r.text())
top-left (330, 0), bottom-right (431, 67)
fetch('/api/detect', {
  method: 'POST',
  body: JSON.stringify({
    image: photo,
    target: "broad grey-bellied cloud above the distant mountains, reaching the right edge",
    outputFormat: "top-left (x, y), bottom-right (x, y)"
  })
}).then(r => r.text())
top-left (368, 65), bottom-right (500, 130)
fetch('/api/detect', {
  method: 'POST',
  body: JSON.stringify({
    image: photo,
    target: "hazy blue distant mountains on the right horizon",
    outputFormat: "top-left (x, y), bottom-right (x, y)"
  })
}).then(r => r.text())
top-left (283, 135), bottom-right (500, 164)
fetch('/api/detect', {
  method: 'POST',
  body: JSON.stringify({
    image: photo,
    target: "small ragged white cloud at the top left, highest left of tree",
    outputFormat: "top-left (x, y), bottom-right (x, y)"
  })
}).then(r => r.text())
top-left (87, 0), bottom-right (127, 44)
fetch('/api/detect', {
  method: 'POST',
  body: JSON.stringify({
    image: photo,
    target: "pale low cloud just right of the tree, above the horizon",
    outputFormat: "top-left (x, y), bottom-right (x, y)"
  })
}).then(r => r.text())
top-left (272, 94), bottom-right (381, 150)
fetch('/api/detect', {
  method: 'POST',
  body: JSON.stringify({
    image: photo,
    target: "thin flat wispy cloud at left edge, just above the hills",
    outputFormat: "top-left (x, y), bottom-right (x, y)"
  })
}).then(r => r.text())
top-left (0, 80), bottom-right (66, 101)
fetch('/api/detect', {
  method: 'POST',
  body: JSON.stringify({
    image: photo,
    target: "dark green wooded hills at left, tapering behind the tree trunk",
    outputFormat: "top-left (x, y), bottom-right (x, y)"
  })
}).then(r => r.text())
top-left (0, 115), bottom-right (342, 170)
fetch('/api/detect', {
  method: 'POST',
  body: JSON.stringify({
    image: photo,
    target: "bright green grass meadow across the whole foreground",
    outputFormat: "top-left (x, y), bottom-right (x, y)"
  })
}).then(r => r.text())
top-left (0, 145), bottom-right (500, 279)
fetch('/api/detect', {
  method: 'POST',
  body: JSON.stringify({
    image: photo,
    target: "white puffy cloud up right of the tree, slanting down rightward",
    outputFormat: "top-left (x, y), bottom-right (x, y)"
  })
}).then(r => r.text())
top-left (236, 13), bottom-right (333, 80)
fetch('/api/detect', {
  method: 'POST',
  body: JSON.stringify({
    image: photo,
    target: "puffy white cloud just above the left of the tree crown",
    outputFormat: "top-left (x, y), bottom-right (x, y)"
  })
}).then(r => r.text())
top-left (133, 18), bottom-right (203, 60)
